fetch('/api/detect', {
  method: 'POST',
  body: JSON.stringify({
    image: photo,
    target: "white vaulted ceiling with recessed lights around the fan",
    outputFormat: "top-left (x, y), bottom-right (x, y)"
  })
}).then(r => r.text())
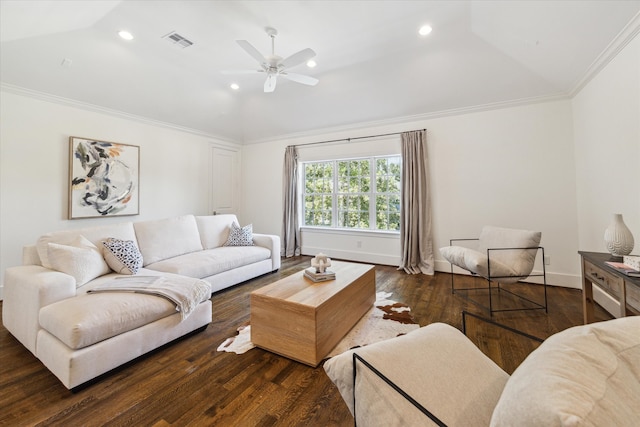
top-left (0, 0), bottom-right (640, 143)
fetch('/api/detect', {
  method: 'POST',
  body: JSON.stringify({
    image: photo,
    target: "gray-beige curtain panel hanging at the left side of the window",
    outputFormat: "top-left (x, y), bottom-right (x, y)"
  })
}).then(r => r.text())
top-left (280, 145), bottom-right (300, 257)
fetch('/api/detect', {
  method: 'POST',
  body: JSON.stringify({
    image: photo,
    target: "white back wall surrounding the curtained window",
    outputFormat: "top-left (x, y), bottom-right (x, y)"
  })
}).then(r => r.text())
top-left (242, 100), bottom-right (579, 286)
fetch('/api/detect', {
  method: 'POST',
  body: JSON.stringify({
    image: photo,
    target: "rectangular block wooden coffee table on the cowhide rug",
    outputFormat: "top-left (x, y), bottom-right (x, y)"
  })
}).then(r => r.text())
top-left (251, 261), bottom-right (376, 367)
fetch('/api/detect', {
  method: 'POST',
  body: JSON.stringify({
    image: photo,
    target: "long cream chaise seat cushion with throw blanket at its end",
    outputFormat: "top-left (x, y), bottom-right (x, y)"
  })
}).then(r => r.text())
top-left (39, 292), bottom-right (176, 349)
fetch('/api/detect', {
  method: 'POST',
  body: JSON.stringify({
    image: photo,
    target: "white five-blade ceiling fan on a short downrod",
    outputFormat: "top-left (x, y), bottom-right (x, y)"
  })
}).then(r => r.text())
top-left (222, 27), bottom-right (318, 92)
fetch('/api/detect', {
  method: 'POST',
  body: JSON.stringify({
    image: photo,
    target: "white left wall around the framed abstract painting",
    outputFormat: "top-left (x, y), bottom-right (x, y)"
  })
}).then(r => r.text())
top-left (0, 91), bottom-right (240, 297)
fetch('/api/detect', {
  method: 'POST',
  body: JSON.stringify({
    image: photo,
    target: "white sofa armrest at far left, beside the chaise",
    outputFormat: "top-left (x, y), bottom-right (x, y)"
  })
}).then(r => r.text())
top-left (2, 265), bottom-right (76, 355)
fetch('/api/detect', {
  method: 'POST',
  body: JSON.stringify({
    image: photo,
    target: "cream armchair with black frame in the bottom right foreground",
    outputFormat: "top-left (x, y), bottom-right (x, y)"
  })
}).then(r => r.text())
top-left (324, 316), bottom-right (640, 427)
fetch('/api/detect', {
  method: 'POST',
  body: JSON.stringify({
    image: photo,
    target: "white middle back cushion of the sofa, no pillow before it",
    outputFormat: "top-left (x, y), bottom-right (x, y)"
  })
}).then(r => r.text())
top-left (133, 215), bottom-right (203, 266)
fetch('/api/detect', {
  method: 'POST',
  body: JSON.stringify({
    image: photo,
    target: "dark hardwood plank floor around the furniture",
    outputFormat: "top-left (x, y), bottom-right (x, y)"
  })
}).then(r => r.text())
top-left (0, 257), bottom-right (611, 426)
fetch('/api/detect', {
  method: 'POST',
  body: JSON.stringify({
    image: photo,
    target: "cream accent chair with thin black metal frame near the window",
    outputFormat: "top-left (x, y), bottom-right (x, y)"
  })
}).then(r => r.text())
top-left (440, 226), bottom-right (547, 316)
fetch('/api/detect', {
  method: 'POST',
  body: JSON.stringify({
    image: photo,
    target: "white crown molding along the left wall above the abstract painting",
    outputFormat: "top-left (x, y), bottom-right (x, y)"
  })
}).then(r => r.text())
top-left (0, 82), bottom-right (241, 146)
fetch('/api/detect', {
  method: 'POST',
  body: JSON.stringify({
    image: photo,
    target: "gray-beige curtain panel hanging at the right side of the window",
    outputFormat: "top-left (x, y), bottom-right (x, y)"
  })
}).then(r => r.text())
top-left (398, 130), bottom-right (434, 274)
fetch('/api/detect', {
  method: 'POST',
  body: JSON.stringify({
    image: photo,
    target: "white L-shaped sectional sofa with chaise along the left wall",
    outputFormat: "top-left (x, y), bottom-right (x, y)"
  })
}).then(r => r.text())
top-left (2, 215), bottom-right (280, 389)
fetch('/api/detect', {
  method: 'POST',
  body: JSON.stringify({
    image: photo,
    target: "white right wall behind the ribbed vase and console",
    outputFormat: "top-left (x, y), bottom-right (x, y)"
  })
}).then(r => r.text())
top-left (572, 36), bottom-right (640, 254)
